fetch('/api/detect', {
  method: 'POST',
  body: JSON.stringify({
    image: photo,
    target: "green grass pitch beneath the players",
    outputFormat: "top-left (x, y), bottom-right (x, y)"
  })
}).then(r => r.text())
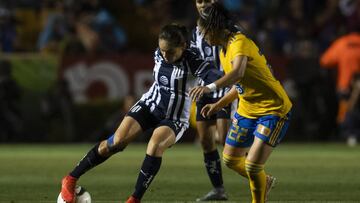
top-left (0, 144), bottom-right (360, 203)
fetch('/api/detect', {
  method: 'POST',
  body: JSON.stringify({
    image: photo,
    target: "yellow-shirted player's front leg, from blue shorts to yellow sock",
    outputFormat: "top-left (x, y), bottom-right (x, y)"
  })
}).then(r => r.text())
top-left (245, 114), bottom-right (289, 203)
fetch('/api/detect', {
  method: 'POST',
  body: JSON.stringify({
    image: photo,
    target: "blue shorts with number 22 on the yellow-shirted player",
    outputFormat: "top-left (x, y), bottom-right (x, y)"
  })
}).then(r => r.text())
top-left (225, 113), bottom-right (291, 148)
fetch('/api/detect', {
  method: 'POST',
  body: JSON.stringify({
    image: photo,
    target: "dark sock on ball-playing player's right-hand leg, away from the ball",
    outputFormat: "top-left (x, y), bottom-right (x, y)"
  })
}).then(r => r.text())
top-left (132, 154), bottom-right (161, 200)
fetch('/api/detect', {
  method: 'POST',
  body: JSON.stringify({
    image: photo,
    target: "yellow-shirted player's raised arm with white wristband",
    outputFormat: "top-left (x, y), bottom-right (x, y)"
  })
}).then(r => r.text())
top-left (190, 55), bottom-right (248, 100)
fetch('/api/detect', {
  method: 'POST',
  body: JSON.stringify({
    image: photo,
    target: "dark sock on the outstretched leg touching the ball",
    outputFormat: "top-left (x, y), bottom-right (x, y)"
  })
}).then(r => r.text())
top-left (70, 143), bottom-right (109, 178)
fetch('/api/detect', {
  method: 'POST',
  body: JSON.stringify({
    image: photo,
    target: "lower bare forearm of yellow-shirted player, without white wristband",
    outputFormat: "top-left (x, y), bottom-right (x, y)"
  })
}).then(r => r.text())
top-left (200, 86), bottom-right (238, 117)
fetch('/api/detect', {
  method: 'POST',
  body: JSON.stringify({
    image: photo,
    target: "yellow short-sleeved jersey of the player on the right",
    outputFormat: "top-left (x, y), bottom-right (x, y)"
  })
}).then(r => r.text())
top-left (220, 33), bottom-right (292, 119)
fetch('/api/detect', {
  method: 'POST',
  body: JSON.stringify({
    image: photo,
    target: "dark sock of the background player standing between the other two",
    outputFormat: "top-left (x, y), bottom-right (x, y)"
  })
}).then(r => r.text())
top-left (204, 150), bottom-right (223, 188)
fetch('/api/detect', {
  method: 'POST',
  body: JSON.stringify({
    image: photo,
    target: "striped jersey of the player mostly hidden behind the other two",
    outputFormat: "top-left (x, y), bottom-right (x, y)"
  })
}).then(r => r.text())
top-left (190, 26), bottom-right (229, 98)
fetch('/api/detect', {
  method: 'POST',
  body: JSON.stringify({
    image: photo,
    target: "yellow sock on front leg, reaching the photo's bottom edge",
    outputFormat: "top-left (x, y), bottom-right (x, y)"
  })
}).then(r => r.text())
top-left (245, 160), bottom-right (266, 203)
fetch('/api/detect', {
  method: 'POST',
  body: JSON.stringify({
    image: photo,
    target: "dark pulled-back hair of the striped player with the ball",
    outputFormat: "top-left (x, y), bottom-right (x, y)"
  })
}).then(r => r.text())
top-left (159, 23), bottom-right (188, 47)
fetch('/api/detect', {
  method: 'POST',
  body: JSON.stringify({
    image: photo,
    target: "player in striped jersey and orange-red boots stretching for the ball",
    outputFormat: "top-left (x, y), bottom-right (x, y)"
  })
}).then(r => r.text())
top-left (61, 24), bottom-right (222, 203)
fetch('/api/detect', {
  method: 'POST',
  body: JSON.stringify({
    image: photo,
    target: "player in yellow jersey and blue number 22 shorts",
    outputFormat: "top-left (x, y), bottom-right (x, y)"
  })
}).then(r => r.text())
top-left (190, 3), bottom-right (292, 203)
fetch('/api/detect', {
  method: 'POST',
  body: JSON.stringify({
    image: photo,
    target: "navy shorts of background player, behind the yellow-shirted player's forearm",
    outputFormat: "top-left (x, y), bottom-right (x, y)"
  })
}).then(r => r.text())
top-left (196, 98), bottom-right (231, 121)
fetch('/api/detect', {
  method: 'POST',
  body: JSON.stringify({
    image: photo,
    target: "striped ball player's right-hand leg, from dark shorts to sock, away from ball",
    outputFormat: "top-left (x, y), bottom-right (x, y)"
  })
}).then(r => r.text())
top-left (127, 121), bottom-right (186, 203)
